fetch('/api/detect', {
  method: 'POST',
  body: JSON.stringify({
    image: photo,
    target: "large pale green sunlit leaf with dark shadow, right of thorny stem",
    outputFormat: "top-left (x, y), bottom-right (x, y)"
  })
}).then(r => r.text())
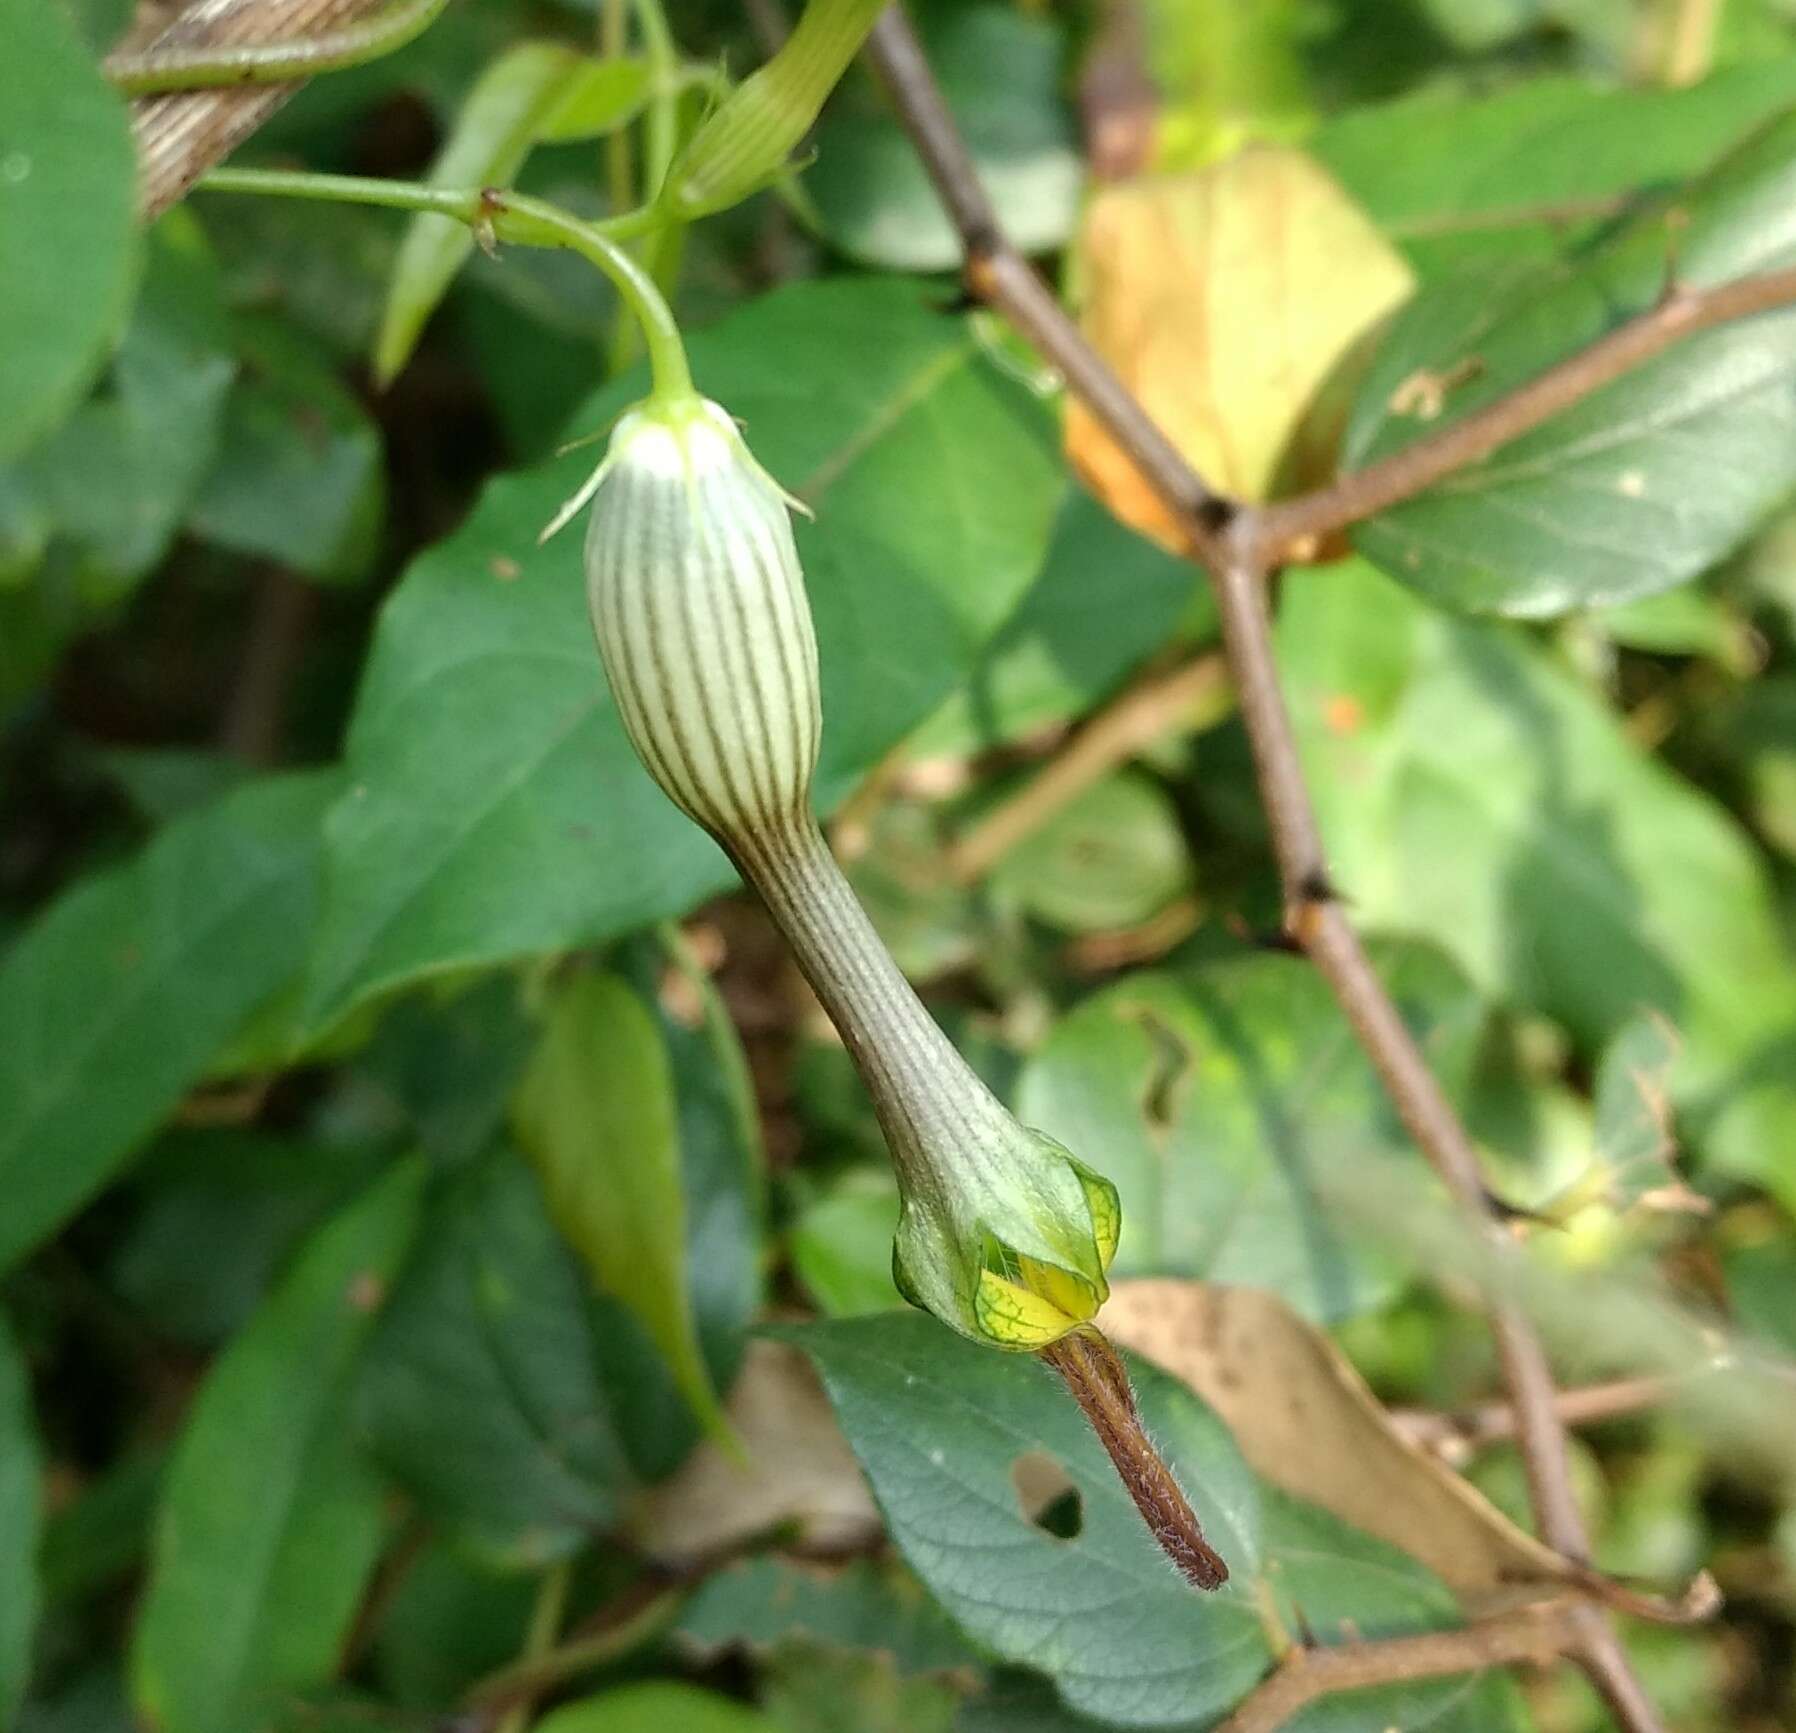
top-left (1279, 564), bottom-right (1796, 1198)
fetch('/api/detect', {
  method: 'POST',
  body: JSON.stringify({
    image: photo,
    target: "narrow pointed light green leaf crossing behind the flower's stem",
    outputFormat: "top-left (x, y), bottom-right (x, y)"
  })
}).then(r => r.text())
top-left (374, 41), bottom-right (610, 386)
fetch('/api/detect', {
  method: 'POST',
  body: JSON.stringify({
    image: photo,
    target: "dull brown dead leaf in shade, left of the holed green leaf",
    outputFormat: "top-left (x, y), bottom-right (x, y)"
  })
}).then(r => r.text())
top-left (627, 1338), bottom-right (880, 1568)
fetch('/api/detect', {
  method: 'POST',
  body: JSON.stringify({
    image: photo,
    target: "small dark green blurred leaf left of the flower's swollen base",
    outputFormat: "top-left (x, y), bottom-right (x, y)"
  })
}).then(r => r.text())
top-left (192, 320), bottom-right (384, 578)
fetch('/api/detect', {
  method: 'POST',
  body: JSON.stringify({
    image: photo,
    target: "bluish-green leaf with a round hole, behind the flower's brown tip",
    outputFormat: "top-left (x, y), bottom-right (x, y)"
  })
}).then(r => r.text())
top-left (781, 1313), bottom-right (1518, 1733)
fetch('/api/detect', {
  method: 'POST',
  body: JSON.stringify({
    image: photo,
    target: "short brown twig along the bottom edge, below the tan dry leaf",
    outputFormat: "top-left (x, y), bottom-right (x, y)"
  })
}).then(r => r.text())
top-left (1216, 1602), bottom-right (1584, 1733)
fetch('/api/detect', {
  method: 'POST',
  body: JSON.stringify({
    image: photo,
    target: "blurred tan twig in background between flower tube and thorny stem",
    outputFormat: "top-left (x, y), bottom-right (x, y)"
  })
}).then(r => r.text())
top-left (948, 655), bottom-right (1228, 885)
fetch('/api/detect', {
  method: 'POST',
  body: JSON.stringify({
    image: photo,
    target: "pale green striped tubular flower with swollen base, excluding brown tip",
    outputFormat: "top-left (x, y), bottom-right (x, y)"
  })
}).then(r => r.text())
top-left (559, 395), bottom-right (1121, 1349)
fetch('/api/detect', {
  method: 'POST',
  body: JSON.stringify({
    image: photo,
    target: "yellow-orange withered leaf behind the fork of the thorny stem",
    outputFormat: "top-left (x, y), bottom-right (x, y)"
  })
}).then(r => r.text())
top-left (1065, 145), bottom-right (1413, 551)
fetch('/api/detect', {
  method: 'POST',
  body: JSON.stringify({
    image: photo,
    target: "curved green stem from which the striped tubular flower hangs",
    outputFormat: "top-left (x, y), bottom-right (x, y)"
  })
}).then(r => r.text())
top-left (199, 169), bottom-right (693, 399)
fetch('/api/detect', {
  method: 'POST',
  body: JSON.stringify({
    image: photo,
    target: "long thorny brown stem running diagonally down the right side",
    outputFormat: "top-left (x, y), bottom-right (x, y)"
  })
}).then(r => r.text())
top-left (869, 5), bottom-right (1688, 1733)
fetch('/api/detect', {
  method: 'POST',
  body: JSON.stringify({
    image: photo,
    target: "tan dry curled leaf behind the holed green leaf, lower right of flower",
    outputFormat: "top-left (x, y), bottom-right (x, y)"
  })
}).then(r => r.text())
top-left (1097, 1280), bottom-right (1568, 1611)
